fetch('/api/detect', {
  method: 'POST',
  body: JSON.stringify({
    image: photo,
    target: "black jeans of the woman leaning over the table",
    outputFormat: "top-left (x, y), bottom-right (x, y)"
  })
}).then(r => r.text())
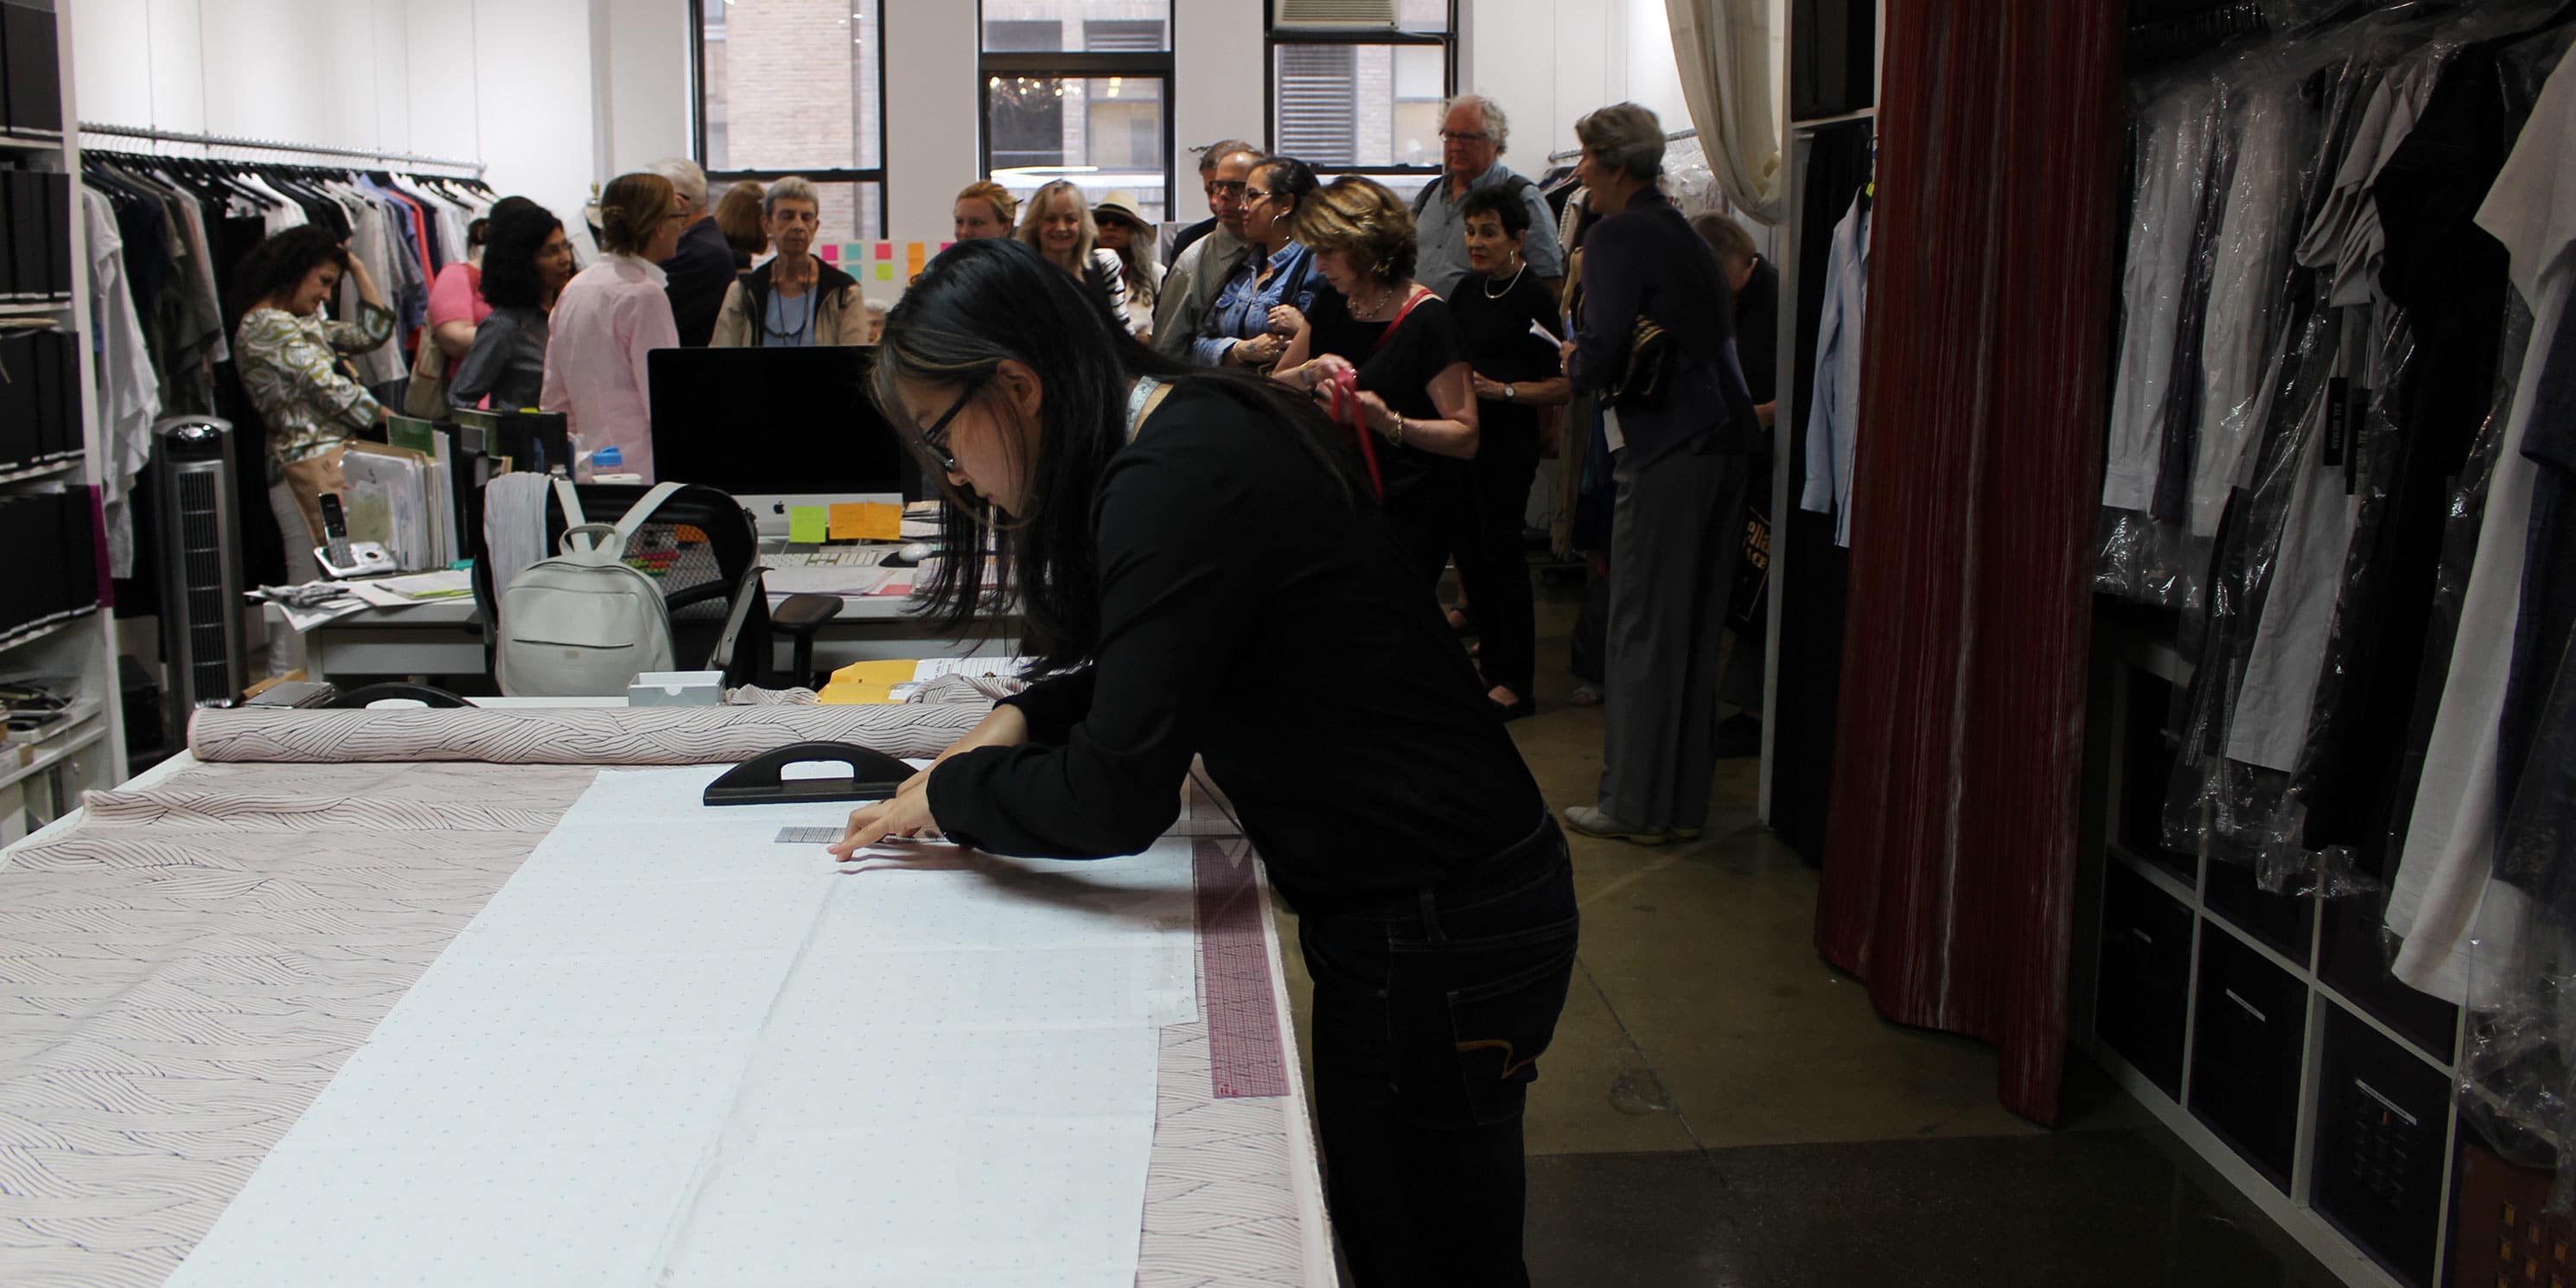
top-left (1298, 817), bottom-right (1577, 1288)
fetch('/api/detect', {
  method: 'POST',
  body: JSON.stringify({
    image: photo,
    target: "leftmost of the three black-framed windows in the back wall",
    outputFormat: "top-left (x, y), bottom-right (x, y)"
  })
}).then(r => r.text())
top-left (691, 0), bottom-right (886, 242)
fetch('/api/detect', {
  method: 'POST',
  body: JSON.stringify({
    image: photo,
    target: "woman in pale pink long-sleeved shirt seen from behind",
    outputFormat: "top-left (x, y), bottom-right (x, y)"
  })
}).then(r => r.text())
top-left (539, 175), bottom-right (688, 481)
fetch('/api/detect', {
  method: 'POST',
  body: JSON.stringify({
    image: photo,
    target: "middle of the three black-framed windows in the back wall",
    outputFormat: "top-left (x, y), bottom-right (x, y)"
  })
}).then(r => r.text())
top-left (981, 0), bottom-right (1172, 219)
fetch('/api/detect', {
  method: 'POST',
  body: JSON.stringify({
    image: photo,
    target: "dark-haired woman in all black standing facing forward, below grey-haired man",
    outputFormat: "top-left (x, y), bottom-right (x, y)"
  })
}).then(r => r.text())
top-left (1448, 188), bottom-right (1572, 718)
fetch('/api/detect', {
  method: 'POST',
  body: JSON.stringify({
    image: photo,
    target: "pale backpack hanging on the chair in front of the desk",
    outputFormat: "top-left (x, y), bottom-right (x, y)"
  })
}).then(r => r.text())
top-left (492, 479), bottom-right (680, 698)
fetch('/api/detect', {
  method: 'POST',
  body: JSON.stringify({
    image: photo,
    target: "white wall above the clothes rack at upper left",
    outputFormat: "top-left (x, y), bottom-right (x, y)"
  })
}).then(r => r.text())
top-left (65, 0), bottom-right (605, 258)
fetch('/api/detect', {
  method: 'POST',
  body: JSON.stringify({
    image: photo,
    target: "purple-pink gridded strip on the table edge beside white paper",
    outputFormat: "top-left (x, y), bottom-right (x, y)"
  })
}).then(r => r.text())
top-left (1190, 838), bottom-right (1288, 1100)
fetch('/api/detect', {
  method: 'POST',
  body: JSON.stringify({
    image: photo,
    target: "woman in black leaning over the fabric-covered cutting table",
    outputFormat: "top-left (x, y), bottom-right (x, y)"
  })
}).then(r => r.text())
top-left (832, 242), bottom-right (1577, 1285)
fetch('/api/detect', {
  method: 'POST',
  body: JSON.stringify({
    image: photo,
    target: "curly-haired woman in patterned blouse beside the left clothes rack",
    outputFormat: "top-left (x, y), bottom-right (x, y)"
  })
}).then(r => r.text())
top-left (232, 224), bottom-right (394, 592)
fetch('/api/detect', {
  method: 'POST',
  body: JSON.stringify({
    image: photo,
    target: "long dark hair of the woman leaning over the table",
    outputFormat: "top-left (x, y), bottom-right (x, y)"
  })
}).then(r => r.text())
top-left (876, 237), bottom-right (1365, 675)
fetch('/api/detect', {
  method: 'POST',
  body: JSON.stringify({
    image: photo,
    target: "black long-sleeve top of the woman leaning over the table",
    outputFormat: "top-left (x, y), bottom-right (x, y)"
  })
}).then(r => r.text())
top-left (930, 384), bottom-right (1546, 907)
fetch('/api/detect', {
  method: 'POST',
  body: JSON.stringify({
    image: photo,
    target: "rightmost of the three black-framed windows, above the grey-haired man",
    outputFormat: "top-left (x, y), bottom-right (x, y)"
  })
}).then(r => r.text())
top-left (1270, 0), bottom-right (1456, 175)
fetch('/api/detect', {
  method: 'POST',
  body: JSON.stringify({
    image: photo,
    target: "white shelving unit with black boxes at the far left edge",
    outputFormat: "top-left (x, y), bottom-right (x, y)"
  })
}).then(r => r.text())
top-left (0, 5), bottom-right (126, 842)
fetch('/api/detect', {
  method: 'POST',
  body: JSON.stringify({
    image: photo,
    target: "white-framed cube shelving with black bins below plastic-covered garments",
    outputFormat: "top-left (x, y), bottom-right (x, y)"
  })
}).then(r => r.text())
top-left (2076, 608), bottom-right (2462, 1288)
